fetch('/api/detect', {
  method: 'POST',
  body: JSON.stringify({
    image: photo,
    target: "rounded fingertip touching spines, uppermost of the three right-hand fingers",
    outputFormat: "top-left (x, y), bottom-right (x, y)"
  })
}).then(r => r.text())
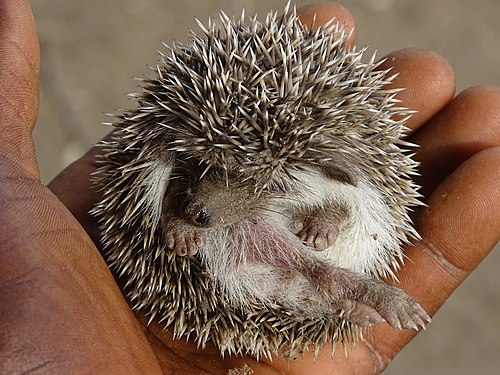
top-left (380, 48), bottom-right (455, 130)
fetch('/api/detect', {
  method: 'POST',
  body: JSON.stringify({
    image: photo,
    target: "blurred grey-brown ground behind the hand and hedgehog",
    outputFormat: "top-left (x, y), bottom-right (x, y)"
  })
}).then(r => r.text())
top-left (31, 0), bottom-right (500, 375)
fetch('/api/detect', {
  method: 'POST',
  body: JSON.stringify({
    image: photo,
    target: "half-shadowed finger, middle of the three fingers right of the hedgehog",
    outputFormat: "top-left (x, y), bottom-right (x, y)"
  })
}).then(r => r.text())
top-left (411, 86), bottom-right (500, 195)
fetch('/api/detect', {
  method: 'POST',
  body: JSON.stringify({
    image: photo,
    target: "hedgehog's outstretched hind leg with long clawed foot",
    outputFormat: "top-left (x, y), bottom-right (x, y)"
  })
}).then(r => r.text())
top-left (242, 216), bottom-right (430, 329)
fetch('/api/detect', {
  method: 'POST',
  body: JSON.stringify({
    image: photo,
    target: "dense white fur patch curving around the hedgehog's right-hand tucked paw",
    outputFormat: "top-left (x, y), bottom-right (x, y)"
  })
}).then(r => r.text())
top-left (290, 171), bottom-right (401, 274)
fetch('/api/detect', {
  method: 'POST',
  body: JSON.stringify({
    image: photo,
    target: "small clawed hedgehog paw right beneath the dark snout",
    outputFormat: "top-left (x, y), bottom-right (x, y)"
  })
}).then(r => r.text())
top-left (165, 218), bottom-right (204, 256)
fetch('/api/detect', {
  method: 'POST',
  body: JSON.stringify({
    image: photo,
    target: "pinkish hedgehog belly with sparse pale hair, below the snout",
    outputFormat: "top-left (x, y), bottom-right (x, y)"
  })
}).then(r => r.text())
top-left (199, 214), bottom-right (334, 318)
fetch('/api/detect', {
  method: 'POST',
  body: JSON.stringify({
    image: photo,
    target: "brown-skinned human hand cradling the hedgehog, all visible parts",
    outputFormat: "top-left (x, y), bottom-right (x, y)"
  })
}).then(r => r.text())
top-left (0, 0), bottom-right (500, 374)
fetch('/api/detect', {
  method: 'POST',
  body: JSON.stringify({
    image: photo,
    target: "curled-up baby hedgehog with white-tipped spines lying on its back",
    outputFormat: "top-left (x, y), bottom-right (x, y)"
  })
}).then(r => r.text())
top-left (94, 7), bottom-right (429, 358)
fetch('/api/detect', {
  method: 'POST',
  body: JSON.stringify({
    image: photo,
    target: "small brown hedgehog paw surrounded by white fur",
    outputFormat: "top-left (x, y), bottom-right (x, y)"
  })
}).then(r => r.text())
top-left (295, 203), bottom-right (348, 250)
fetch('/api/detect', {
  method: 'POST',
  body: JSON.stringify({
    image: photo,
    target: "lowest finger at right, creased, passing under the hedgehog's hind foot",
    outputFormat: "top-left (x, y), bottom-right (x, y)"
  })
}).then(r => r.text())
top-left (366, 147), bottom-right (500, 370)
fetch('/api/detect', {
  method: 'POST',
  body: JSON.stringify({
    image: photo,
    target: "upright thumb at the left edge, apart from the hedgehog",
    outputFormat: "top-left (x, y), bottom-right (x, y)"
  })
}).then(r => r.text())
top-left (0, 0), bottom-right (40, 179)
